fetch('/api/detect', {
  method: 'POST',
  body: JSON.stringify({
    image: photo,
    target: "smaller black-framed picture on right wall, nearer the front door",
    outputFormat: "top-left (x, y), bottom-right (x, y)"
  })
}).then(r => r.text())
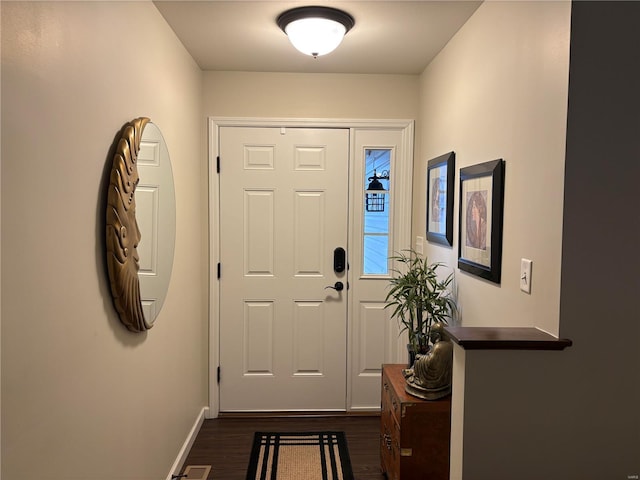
top-left (426, 152), bottom-right (456, 246)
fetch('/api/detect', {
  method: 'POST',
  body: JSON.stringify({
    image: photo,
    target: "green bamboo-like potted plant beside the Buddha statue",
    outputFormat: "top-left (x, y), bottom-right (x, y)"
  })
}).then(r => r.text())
top-left (385, 250), bottom-right (456, 366)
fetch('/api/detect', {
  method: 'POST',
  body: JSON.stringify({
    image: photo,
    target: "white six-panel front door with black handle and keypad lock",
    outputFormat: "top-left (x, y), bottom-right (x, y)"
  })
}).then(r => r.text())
top-left (219, 126), bottom-right (349, 411)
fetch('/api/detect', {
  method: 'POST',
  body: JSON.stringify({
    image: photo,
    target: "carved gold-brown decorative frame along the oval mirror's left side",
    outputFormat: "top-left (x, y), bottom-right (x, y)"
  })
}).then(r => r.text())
top-left (106, 117), bottom-right (153, 332)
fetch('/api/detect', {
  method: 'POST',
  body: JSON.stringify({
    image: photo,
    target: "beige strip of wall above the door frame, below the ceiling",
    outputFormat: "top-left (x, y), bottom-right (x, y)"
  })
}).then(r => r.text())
top-left (203, 72), bottom-right (418, 119)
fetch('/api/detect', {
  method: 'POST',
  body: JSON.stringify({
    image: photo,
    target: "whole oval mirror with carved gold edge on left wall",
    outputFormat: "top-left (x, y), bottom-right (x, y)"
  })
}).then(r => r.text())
top-left (107, 118), bottom-right (176, 332)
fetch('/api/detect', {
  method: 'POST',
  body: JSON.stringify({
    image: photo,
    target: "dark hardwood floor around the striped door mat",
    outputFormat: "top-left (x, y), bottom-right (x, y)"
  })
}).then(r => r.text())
top-left (183, 415), bottom-right (385, 480)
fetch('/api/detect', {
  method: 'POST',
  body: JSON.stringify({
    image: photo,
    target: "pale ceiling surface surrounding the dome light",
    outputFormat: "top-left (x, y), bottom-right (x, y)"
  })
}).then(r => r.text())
top-left (154, 0), bottom-right (481, 74)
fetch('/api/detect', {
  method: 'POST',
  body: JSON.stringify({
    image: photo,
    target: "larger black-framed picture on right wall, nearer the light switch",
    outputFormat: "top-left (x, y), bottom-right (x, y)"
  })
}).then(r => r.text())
top-left (458, 159), bottom-right (505, 284)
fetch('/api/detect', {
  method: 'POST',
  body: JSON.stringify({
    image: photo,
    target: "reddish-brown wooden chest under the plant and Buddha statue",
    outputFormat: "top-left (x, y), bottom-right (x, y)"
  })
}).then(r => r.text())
top-left (380, 364), bottom-right (451, 480)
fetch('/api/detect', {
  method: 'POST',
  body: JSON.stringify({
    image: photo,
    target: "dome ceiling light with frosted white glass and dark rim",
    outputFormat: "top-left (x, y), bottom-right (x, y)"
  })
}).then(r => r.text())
top-left (276, 6), bottom-right (356, 58)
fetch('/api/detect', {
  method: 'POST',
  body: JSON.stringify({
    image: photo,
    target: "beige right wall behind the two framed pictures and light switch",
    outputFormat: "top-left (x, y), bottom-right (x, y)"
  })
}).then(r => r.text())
top-left (413, 2), bottom-right (570, 334)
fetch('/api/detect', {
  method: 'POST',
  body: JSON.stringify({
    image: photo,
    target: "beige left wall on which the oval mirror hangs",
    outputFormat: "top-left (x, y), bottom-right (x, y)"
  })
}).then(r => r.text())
top-left (2, 2), bottom-right (208, 480)
